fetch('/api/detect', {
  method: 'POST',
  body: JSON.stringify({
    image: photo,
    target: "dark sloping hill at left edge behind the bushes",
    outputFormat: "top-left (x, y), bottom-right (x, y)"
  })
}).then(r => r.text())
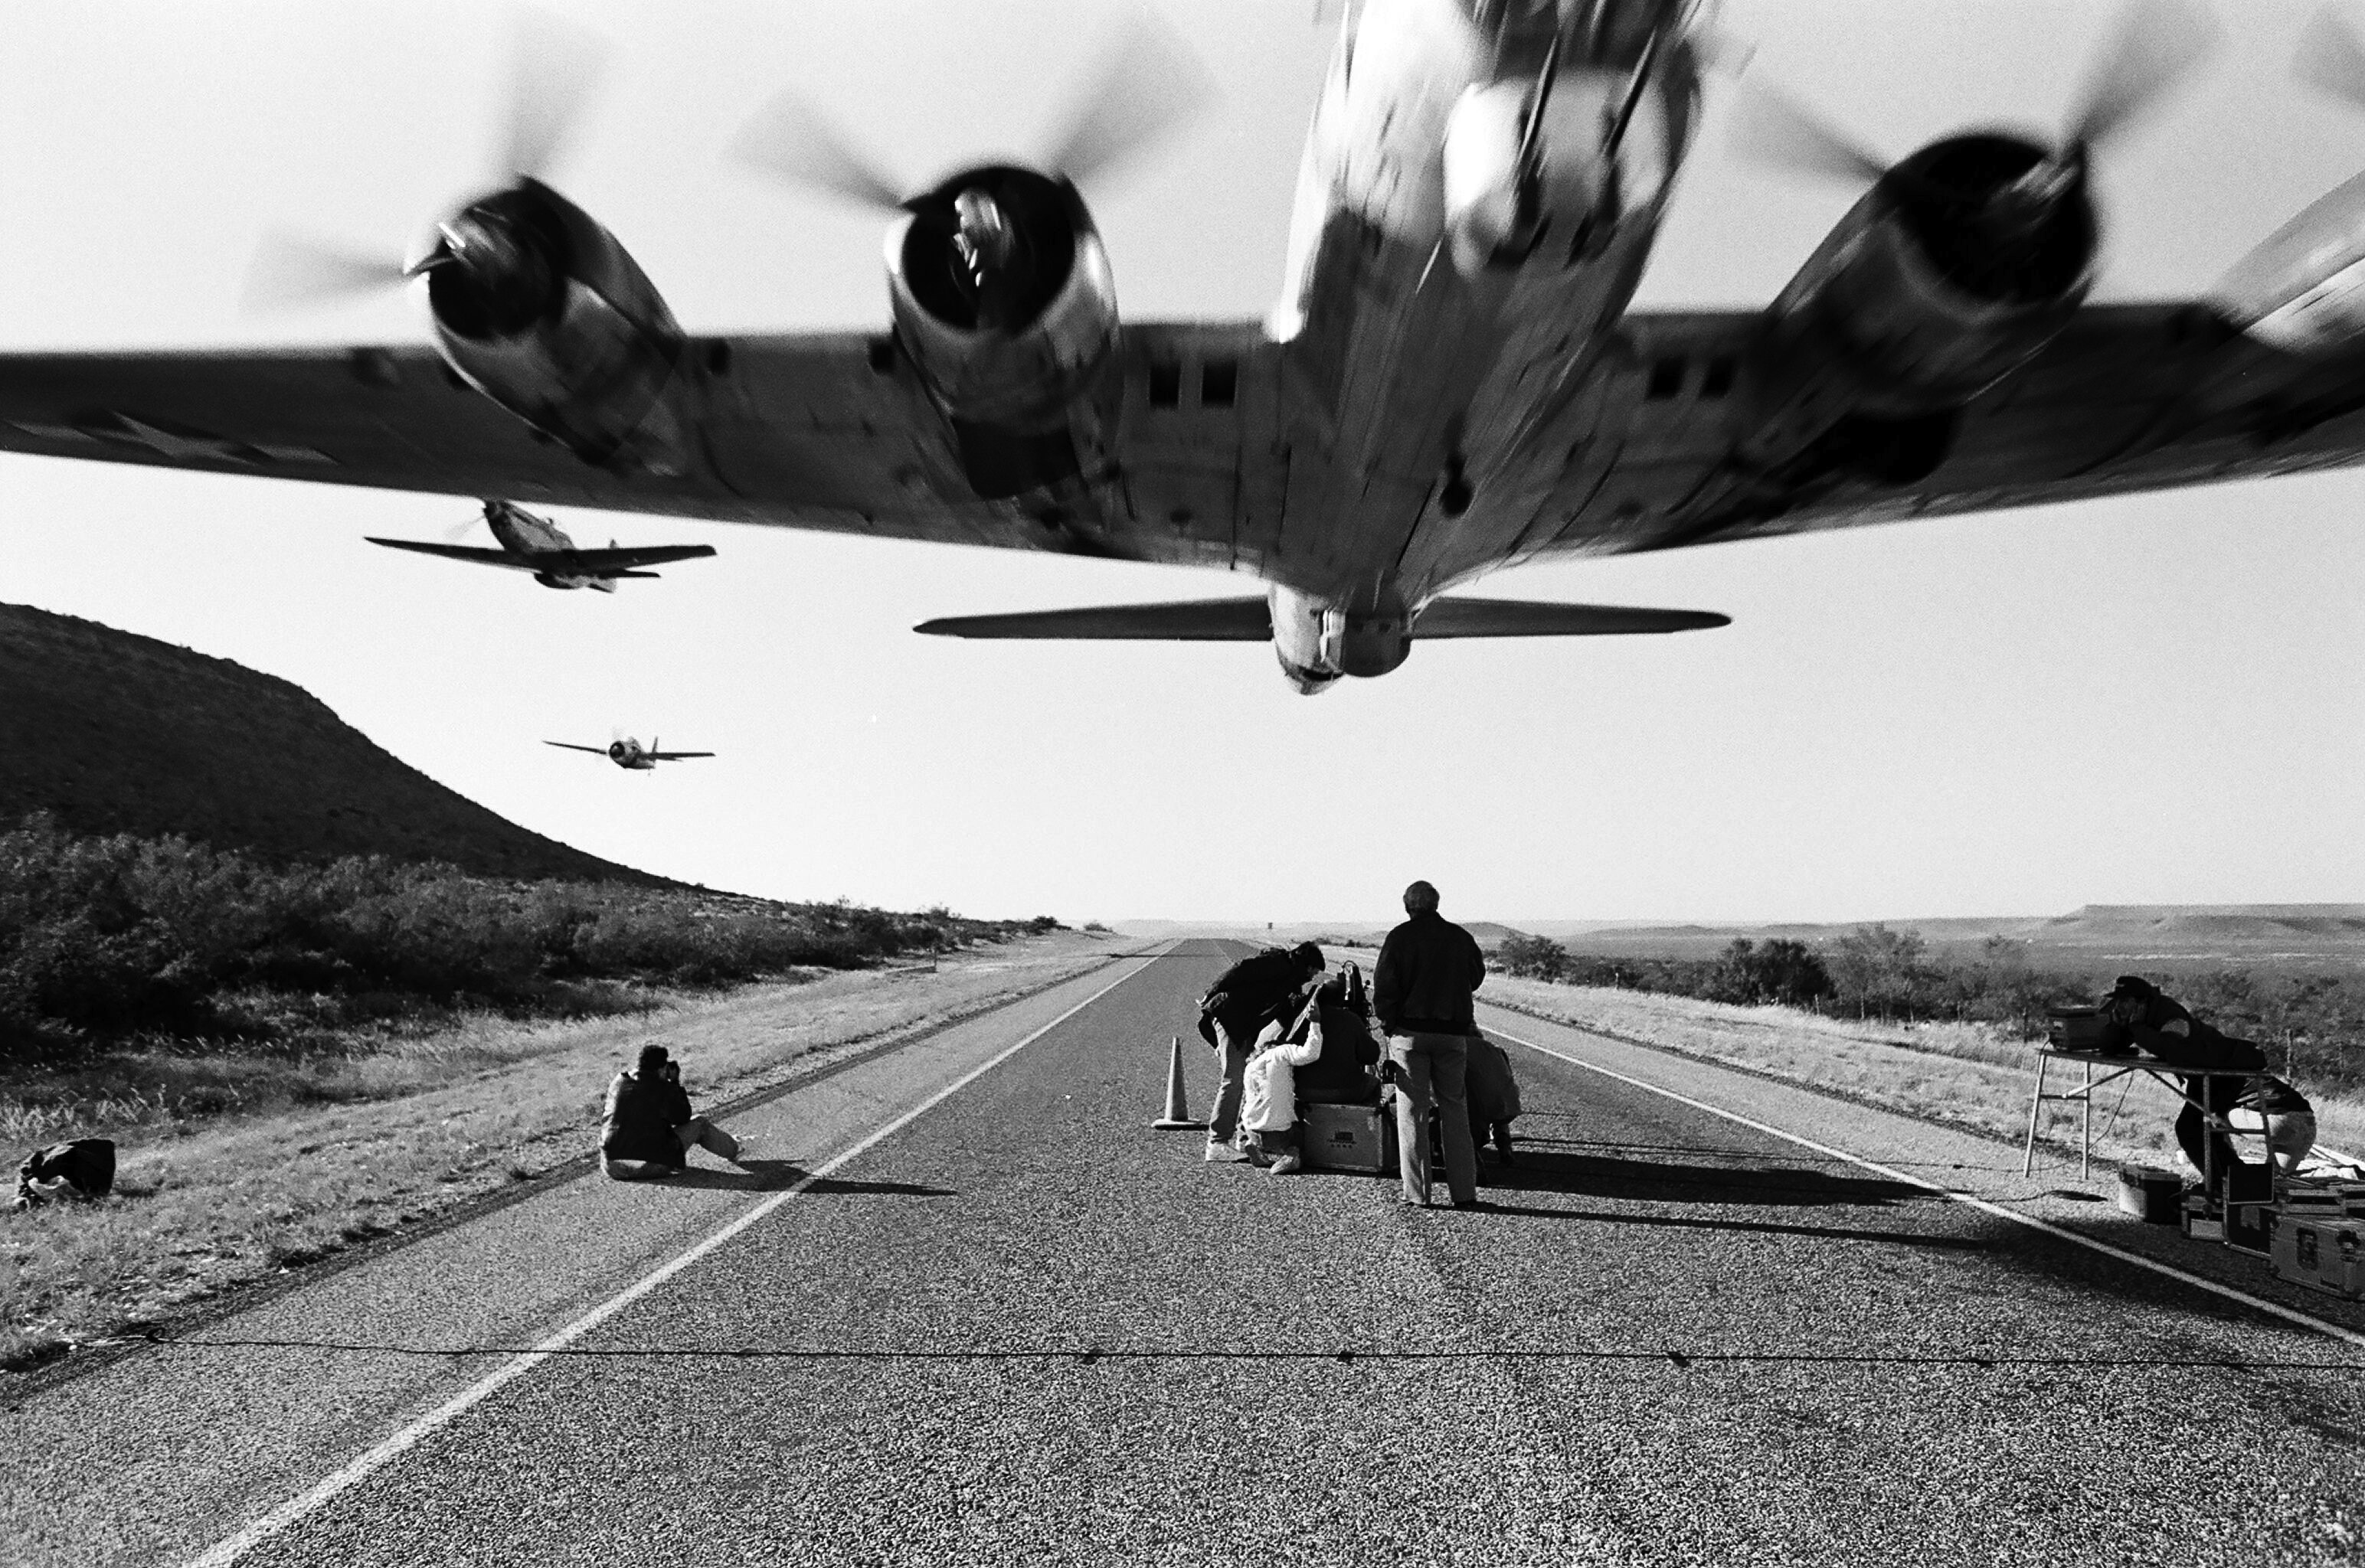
top-left (0, 606), bottom-right (665, 887)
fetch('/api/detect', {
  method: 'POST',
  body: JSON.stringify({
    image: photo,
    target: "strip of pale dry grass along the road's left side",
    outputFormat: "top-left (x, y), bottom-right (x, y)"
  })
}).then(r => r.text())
top-left (0, 932), bottom-right (1121, 1370)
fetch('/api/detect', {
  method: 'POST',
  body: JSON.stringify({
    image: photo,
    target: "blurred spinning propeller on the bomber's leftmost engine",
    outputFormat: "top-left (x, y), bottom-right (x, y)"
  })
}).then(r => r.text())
top-left (244, 9), bottom-right (608, 310)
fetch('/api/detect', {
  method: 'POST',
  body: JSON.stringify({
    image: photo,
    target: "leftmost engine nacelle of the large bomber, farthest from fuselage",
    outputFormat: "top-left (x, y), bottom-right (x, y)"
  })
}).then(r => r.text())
top-left (419, 180), bottom-right (683, 473)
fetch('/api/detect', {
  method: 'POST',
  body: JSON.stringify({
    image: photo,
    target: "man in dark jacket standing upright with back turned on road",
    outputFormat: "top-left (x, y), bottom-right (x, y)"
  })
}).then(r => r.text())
top-left (1372, 882), bottom-right (1485, 1208)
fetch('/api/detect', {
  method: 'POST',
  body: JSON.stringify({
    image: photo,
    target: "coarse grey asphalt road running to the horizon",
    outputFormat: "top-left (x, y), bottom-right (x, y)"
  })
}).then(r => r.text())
top-left (0, 941), bottom-right (2365, 1568)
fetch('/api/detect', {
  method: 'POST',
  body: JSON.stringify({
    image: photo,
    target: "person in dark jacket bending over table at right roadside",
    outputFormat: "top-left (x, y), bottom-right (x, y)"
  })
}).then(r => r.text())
top-left (2102, 975), bottom-right (2315, 1201)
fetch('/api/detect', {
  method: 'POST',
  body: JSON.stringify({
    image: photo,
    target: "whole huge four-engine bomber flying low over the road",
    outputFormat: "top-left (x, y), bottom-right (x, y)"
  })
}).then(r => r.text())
top-left (14, 0), bottom-right (2365, 691)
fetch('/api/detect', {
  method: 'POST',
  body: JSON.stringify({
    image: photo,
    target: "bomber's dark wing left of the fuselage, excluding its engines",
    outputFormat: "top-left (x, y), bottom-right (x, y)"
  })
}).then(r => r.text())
top-left (0, 324), bottom-right (1277, 563)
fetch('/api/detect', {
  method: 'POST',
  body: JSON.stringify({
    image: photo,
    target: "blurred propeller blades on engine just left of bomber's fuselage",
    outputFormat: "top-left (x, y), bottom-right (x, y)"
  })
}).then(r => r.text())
top-left (733, 11), bottom-right (1213, 213)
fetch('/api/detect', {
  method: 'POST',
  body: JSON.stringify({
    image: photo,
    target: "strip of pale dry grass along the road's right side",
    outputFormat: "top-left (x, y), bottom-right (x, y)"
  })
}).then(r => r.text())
top-left (1480, 975), bottom-right (2365, 1164)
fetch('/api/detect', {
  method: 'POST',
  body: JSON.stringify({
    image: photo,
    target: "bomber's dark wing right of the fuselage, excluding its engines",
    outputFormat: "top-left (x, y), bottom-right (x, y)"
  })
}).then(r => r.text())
top-left (1518, 300), bottom-right (2365, 558)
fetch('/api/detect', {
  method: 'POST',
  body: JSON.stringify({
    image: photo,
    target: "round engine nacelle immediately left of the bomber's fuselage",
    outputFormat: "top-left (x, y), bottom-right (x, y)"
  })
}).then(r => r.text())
top-left (887, 165), bottom-right (1119, 435)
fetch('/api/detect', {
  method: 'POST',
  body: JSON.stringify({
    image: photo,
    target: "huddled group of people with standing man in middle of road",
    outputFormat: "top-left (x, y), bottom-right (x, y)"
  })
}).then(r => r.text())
top-left (1199, 882), bottom-right (1518, 1208)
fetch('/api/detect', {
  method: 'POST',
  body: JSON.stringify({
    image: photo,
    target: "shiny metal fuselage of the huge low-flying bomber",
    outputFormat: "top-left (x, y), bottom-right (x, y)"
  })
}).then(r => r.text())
top-left (1254, 0), bottom-right (1698, 691)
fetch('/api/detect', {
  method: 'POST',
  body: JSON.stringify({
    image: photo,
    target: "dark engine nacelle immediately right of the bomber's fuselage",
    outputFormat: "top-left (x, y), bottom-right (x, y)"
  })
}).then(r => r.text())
top-left (1750, 135), bottom-right (2098, 423)
